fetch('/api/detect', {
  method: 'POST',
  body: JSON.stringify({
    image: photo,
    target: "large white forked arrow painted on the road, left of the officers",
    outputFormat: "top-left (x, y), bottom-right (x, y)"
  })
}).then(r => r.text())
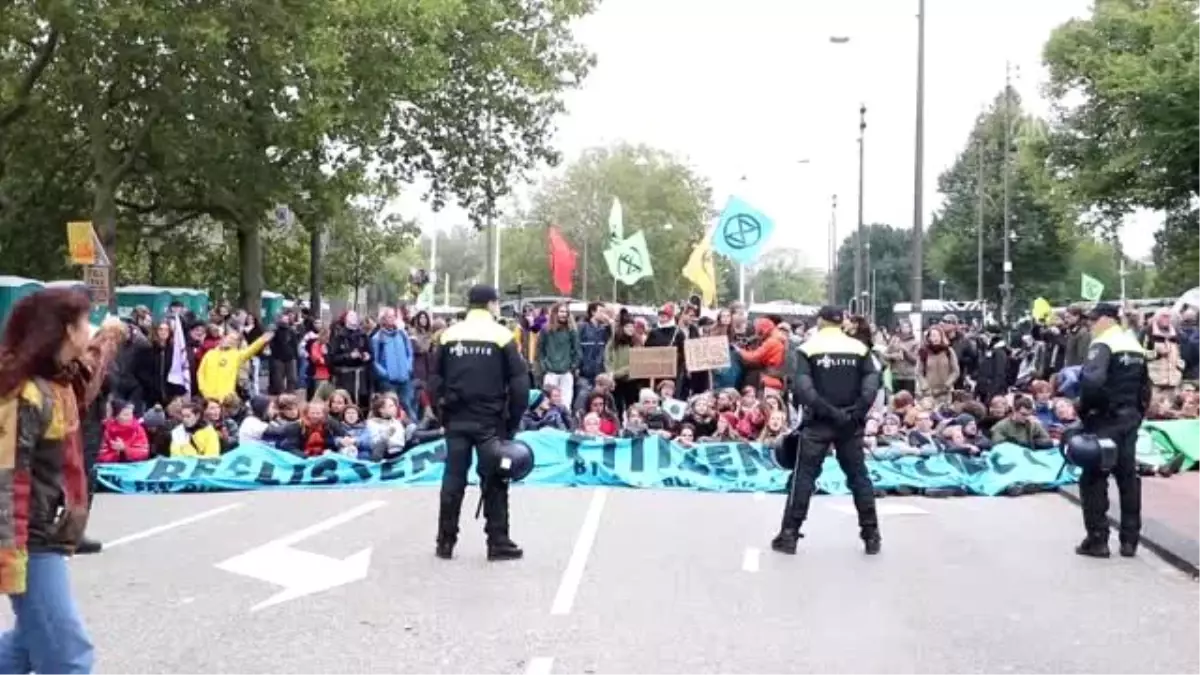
top-left (217, 501), bottom-right (386, 611)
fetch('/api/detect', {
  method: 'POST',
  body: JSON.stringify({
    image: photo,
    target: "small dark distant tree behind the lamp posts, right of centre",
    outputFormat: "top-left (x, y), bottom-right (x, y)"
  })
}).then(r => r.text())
top-left (836, 223), bottom-right (938, 325)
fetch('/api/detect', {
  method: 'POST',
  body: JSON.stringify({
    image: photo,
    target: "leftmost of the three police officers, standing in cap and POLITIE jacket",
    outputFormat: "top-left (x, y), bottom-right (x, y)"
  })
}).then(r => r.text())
top-left (430, 285), bottom-right (529, 560)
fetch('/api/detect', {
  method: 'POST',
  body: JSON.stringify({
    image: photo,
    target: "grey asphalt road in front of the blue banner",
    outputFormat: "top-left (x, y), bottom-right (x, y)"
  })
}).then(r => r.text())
top-left (0, 489), bottom-right (1200, 675)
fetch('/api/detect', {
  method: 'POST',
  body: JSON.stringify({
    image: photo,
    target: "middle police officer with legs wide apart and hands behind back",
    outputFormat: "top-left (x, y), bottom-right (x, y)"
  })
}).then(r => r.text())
top-left (770, 306), bottom-right (882, 555)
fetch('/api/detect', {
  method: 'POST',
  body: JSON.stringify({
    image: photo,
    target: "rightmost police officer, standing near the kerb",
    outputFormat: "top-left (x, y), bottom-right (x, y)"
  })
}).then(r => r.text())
top-left (1075, 303), bottom-right (1151, 557)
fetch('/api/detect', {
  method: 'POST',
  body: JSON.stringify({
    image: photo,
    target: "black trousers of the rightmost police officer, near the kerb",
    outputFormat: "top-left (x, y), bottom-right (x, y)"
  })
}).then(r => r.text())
top-left (1079, 410), bottom-right (1142, 544)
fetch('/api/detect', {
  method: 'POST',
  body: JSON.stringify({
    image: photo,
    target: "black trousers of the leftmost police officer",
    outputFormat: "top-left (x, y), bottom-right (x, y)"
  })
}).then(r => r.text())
top-left (438, 425), bottom-right (509, 542)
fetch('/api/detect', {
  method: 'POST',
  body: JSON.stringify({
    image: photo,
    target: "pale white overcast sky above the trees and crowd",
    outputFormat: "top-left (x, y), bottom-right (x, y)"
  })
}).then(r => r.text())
top-left (397, 0), bottom-right (1158, 267)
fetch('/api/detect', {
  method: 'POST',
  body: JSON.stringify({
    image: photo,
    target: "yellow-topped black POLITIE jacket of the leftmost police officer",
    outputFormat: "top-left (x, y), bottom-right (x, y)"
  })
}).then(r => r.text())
top-left (430, 310), bottom-right (529, 432)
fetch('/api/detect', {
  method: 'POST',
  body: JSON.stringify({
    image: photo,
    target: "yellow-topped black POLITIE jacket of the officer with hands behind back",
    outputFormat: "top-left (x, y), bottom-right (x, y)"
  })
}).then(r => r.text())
top-left (792, 325), bottom-right (880, 424)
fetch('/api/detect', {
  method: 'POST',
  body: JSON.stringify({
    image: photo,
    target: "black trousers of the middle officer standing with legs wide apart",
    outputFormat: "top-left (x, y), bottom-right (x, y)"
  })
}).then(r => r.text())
top-left (784, 422), bottom-right (880, 538)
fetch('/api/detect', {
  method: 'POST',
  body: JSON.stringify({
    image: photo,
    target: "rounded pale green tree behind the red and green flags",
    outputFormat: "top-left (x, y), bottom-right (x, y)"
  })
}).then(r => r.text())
top-left (513, 145), bottom-right (714, 303)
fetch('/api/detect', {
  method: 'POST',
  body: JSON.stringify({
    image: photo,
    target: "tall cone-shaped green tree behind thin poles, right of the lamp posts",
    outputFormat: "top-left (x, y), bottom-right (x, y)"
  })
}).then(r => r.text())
top-left (921, 86), bottom-right (1076, 307)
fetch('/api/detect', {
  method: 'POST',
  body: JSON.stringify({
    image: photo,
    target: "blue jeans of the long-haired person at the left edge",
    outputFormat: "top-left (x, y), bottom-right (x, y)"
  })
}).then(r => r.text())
top-left (0, 552), bottom-right (95, 675)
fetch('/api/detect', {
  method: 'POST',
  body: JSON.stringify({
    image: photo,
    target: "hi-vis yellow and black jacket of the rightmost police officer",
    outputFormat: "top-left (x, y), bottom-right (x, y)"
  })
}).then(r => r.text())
top-left (1079, 325), bottom-right (1151, 417)
